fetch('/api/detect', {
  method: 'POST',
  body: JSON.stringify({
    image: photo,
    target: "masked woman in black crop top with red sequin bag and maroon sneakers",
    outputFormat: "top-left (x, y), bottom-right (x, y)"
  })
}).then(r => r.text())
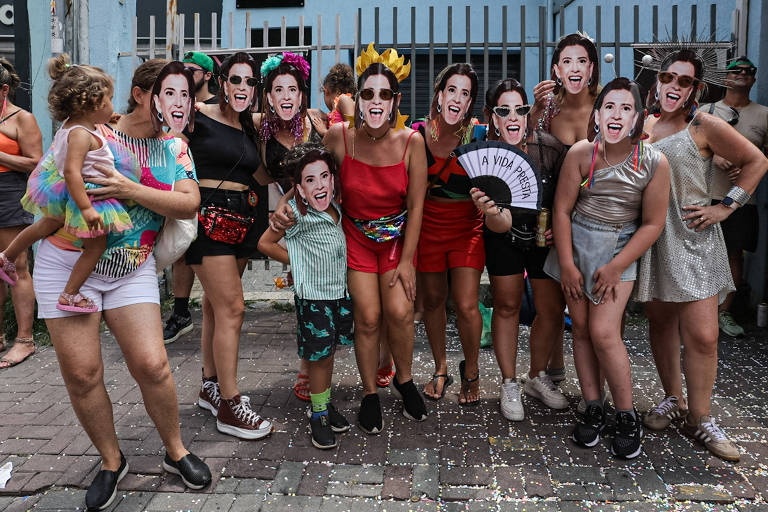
top-left (184, 52), bottom-right (272, 439)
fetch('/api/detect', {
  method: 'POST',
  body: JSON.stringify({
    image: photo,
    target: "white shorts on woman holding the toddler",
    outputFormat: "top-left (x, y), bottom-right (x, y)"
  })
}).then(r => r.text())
top-left (32, 240), bottom-right (160, 318)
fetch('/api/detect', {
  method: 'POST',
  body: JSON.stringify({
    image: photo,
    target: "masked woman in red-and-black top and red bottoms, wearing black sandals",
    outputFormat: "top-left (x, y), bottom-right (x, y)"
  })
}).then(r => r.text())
top-left (418, 63), bottom-right (485, 405)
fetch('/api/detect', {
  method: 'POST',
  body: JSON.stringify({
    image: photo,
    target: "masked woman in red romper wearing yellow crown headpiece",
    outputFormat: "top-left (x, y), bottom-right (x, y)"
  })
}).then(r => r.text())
top-left (324, 45), bottom-right (427, 434)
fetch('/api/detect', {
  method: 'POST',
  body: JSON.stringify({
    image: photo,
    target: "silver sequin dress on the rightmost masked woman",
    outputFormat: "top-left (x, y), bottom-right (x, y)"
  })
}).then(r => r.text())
top-left (634, 119), bottom-right (735, 302)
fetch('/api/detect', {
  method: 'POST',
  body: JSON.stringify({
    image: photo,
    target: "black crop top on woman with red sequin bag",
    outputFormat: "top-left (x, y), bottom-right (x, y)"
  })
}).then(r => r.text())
top-left (184, 112), bottom-right (261, 186)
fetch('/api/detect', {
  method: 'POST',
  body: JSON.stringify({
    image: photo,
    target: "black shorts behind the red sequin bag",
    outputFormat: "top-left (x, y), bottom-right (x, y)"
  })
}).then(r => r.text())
top-left (186, 187), bottom-right (264, 265)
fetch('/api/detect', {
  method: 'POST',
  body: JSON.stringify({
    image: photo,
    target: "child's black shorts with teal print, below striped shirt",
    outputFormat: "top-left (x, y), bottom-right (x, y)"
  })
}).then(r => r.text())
top-left (293, 295), bottom-right (353, 361)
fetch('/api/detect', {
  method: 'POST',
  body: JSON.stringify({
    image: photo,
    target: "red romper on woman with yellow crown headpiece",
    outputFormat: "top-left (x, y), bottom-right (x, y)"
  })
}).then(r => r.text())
top-left (340, 130), bottom-right (416, 274)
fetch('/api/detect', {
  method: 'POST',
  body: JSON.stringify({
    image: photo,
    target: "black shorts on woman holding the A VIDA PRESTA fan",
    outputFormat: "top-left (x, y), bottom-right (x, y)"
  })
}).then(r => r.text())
top-left (485, 232), bottom-right (552, 279)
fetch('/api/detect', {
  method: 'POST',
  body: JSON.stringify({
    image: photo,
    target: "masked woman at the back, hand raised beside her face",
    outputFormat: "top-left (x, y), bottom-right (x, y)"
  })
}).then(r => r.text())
top-left (530, 32), bottom-right (600, 388)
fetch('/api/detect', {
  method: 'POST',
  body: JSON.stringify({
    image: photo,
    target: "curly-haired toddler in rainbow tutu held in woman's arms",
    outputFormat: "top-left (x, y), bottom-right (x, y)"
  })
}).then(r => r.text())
top-left (0, 54), bottom-right (138, 313)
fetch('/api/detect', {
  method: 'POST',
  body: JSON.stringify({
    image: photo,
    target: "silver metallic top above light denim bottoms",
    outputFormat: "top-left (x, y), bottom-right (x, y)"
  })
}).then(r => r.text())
top-left (574, 144), bottom-right (661, 224)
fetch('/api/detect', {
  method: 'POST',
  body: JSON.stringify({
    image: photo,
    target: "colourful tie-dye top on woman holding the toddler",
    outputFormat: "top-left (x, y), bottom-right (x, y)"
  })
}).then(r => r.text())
top-left (49, 125), bottom-right (197, 278)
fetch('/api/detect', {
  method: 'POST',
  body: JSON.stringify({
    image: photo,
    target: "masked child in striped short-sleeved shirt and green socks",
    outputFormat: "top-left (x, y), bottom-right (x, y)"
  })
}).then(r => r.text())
top-left (258, 143), bottom-right (352, 449)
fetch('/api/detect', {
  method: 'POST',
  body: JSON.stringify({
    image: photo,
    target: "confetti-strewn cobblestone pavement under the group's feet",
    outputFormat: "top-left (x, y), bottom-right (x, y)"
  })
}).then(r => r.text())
top-left (0, 306), bottom-right (768, 512)
